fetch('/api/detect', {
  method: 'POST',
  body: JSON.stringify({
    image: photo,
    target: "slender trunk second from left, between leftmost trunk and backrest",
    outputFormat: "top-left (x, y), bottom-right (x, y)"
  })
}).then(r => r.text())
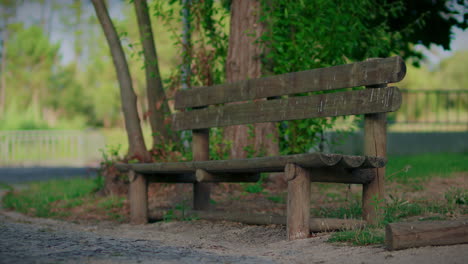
top-left (134, 0), bottom-right (171, 148)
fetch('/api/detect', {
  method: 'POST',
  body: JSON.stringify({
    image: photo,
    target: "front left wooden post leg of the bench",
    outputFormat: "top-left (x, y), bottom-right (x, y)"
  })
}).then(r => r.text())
top-left (128, 171), bottom-right (148, 225)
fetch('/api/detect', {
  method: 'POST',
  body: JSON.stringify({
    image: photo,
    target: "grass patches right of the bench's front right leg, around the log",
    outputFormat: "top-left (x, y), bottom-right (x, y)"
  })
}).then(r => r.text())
top-left (324, 153), bottom-right (468, 245)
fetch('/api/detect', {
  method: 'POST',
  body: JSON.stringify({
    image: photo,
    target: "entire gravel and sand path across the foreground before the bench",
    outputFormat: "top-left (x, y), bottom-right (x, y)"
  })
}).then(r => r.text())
top-left (0, 186), bottom-right (468, 264)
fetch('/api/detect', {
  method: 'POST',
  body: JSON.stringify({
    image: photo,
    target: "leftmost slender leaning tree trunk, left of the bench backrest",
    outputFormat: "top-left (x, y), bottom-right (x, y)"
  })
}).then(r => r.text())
top-left (92, 0), bottom-right (151, 162)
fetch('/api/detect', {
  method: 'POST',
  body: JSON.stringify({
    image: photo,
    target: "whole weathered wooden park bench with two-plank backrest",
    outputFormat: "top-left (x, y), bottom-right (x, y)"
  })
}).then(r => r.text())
top-left (117, 57), bottom-right (406, 239)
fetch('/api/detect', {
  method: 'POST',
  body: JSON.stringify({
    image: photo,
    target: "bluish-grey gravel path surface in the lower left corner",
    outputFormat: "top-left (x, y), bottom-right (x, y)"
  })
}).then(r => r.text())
top-left (0, 212), bottom-right (272, 263)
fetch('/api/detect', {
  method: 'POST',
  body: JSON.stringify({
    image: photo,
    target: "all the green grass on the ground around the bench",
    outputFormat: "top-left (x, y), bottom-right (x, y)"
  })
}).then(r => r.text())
top-left (0, 154), bottom-right (468, 245)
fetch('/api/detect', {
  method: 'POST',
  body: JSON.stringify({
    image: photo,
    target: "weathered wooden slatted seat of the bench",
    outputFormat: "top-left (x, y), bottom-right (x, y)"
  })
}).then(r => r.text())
top-left (116, 152), bottom-right (386, 184)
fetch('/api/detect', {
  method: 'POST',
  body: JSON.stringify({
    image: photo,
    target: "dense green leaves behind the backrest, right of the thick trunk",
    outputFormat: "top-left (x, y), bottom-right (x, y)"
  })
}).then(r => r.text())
top-left (259, 0), bottom-right (408, 154)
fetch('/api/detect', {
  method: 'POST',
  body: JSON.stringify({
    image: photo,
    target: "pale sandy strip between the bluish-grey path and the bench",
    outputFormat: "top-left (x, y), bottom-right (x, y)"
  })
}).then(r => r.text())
top-left (0, 206), bottom-right (468, 264)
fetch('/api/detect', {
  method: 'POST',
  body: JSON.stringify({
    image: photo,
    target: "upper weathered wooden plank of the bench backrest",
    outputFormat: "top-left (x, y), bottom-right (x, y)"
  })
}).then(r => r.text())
top-left (175, 57), bottom-right (406, 109)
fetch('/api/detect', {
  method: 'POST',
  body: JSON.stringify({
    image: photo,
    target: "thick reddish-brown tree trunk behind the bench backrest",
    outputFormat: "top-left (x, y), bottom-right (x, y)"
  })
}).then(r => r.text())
top-left (224, 0), bottom-right (279, 158)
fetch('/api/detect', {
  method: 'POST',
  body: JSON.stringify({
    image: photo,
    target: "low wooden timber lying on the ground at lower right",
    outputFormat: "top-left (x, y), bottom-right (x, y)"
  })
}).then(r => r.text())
top-left (385, 219), bottom-right (468, 250)
